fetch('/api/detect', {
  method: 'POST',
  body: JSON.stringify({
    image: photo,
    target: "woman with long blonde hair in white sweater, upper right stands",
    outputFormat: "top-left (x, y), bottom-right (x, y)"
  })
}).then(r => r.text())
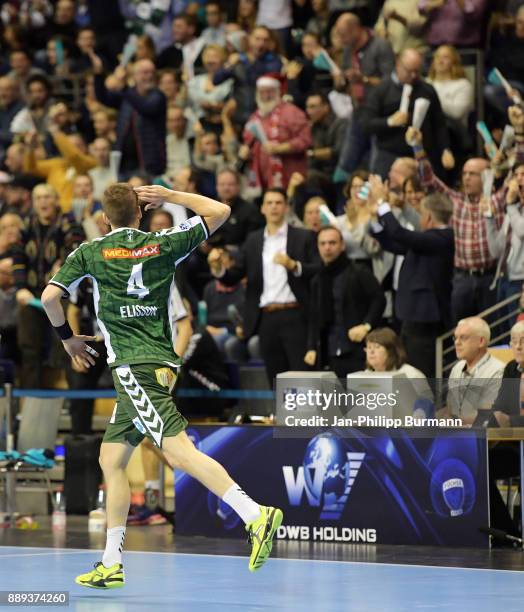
top-left (428, 45), bottom-right (474, 157)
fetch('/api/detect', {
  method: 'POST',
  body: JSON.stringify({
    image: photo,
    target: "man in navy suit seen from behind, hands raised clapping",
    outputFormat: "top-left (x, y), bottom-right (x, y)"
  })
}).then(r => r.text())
top-left (369, 177), bottom-right (455, 378)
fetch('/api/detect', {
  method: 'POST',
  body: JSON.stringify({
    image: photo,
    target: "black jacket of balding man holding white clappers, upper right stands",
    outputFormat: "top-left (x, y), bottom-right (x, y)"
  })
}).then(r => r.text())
top-left (357, 77), bottom-right (449, 167)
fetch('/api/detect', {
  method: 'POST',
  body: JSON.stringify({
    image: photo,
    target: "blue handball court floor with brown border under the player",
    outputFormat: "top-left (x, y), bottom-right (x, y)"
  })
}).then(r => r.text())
top-left (0, 517), bottom-right (524, 612)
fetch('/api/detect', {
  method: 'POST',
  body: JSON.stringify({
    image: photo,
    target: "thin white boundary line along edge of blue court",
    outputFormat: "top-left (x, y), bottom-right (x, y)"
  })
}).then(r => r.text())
top-left (0, 546), bottom-right (524, 574)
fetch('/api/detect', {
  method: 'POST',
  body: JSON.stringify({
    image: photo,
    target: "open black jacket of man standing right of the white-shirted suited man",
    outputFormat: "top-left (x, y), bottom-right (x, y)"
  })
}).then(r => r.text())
top-left (307, 260), bottom-right (386, 363)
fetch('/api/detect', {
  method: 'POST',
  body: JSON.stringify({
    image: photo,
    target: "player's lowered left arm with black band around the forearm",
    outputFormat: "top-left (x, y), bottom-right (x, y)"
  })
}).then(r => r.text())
top-left (42, 285), bottom-right (98, 368)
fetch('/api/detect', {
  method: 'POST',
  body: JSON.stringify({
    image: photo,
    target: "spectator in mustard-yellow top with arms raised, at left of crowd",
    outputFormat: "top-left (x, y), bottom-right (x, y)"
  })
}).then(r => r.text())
top-left (24, 103), bottom-right (97, 212)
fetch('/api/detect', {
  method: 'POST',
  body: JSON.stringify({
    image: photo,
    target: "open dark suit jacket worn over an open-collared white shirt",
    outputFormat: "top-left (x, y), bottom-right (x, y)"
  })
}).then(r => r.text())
top-left (220, 226), bottom-right (320, 338)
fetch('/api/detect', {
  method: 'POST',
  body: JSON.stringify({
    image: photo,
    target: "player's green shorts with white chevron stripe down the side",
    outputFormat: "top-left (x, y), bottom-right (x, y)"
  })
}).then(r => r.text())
top-left (104, 363), bottom-right (187, 448)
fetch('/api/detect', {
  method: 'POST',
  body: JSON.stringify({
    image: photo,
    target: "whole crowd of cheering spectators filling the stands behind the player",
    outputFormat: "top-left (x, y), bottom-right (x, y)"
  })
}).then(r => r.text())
top-left (0, 0), bottom-right (524, 428)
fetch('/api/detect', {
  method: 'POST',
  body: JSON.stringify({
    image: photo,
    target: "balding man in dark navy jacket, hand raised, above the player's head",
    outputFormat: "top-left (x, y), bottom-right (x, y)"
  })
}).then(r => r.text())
top-left (92, 56), bottom-right (166, 178)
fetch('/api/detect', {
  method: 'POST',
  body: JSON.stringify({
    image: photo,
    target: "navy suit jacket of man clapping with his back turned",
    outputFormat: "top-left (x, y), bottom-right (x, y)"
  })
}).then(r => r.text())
top-left (373, 212), bottom-right (455, 326)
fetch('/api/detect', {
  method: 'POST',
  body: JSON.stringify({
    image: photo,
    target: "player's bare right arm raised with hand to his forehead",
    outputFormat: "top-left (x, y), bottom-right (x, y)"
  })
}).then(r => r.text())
top-left (135, 185), bottom-right (231, 234)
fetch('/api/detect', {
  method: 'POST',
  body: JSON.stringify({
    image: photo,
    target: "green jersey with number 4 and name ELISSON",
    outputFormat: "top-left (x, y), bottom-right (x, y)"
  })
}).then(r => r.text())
top-left (49, 217), bottom-right (208, 367)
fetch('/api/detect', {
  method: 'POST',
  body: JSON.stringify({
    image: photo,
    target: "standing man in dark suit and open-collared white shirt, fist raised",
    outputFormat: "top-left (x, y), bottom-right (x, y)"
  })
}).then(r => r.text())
top-left (208, 189), bottom-right (320, 384)
